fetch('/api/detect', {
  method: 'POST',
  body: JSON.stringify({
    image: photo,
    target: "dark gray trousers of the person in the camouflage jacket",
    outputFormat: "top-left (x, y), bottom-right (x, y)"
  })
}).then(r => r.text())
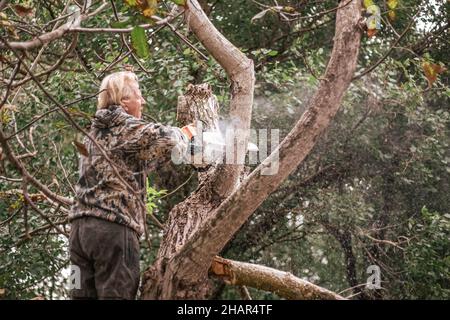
top-left (69, 217), bottom-right (140, 300)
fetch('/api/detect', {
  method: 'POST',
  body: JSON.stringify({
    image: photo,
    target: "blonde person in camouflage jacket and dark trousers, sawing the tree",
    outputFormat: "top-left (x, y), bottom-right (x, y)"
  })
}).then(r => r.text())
top-left (69, 72), bottom-right (195, 299)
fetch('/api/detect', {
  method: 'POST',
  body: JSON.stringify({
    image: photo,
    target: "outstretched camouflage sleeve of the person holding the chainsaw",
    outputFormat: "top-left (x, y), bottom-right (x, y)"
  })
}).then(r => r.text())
top-left (121, 121), bottom-right (189, 163)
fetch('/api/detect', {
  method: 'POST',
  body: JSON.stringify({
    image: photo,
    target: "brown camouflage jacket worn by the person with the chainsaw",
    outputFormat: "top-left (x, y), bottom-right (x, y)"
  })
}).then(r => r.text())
top-left (69, 106), bottom-right (189, 235)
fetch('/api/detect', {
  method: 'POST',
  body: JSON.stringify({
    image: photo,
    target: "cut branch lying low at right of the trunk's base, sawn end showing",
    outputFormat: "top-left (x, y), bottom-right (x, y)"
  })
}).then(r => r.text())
top-left (210, 257), bottom-right (345, 300)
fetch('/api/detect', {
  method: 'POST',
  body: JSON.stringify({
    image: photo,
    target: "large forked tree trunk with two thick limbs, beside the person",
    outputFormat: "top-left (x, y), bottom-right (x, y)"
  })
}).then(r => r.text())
top-left (142, 0), bottom-right (361, 299)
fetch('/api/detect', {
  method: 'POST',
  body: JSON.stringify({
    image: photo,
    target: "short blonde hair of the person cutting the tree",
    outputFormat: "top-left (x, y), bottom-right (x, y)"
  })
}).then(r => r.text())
top-left (97, 71), bottom-right (138, 109)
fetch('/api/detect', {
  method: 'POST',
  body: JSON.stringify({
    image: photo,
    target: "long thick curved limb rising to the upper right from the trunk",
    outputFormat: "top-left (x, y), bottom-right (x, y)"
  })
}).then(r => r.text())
top-left (173, 0), bottom-right (361, 279)
